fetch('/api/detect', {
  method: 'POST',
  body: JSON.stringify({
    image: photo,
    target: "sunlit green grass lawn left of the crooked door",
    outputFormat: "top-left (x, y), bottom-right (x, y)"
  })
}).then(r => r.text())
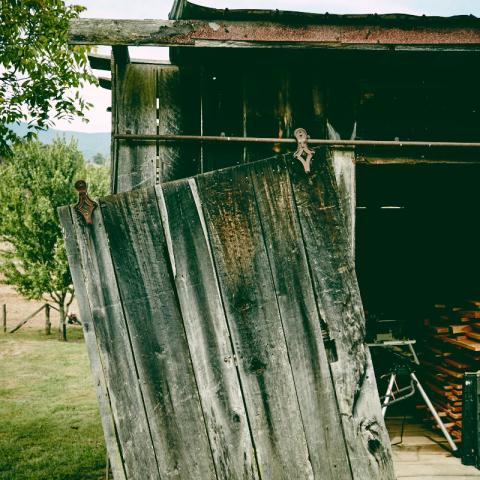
top-left (0, 328), bottom-right (106, 480)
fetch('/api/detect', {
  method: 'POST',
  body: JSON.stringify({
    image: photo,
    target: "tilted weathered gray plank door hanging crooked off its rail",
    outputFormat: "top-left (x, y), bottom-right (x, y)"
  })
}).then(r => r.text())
top-left (60, 150), bottom-right (395, 480)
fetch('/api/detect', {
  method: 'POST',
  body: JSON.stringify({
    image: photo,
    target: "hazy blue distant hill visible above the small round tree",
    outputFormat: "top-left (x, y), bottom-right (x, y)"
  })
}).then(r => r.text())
top-left (9, 124), bottom-right (110, 161)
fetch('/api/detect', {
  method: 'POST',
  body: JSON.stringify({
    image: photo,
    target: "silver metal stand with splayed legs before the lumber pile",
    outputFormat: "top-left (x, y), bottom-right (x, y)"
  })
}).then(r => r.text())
top-left (382, 355), bottom-right (458, 452)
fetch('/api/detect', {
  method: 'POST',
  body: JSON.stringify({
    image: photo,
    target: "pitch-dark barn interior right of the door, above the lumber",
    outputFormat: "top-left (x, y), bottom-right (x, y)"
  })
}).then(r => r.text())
top-left (356, 165), bottom-right (480, 328)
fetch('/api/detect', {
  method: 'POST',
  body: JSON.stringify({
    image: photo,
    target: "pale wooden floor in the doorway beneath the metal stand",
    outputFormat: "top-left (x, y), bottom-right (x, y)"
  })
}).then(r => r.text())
top-left (387, 417), bottom-right (480, 480)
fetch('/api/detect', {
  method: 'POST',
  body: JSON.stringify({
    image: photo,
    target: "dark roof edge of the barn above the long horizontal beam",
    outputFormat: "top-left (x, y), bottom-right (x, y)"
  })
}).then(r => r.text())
top-left (169, 0), bottom-right (480, 28)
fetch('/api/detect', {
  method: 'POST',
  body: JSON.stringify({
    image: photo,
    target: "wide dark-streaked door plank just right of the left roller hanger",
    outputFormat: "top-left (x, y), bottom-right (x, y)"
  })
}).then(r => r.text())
top-left (100, 187), bottom-right (216, 479)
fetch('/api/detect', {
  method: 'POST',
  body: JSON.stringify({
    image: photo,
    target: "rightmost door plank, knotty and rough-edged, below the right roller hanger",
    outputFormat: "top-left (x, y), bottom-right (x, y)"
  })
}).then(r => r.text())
top-left (289, 152), bottom-right (395, 480)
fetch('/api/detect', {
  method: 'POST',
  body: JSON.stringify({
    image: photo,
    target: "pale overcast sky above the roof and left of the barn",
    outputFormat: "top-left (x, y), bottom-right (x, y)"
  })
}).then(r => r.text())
top-left (56, 0), bottom-right (480, 132)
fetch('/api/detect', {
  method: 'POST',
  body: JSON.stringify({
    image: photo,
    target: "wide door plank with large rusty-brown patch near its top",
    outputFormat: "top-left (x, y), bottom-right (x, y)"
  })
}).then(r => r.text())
top-left (197, 166), bottom-right (313, 480)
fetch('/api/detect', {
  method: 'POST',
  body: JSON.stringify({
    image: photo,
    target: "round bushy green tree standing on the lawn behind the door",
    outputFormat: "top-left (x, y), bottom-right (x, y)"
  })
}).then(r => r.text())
top-left (0, 139), bottom-right (108, 340)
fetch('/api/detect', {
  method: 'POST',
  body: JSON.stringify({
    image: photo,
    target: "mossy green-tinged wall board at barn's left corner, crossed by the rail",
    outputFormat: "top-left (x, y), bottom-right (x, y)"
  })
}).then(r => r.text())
top-left (112, 63), bottom-right (158, 192)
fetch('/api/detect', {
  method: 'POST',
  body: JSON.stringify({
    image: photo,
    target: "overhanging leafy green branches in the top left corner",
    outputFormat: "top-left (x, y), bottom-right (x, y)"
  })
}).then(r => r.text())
top-left (0, 0), bottom-right (96, 157)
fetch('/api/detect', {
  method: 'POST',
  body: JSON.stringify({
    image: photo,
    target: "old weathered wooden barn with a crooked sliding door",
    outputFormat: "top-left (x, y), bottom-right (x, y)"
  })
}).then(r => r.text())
top-left (60, 0), bottom-right (480, 480)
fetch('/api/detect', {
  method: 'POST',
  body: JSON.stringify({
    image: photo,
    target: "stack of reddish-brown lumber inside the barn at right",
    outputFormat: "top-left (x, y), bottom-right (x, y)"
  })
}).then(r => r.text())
top-left (419, 300), bottom-right (480, 442)
